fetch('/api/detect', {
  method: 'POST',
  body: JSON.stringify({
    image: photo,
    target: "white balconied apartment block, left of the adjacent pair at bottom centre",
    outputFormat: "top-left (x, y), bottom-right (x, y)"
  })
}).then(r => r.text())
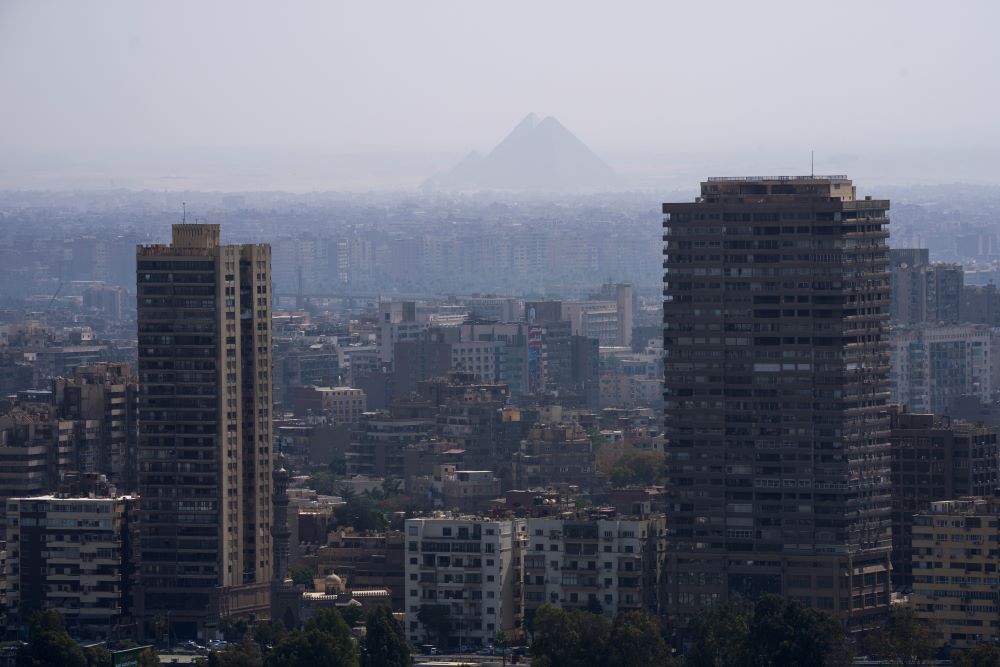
top-left (405, 514), bottom-right (525, 648)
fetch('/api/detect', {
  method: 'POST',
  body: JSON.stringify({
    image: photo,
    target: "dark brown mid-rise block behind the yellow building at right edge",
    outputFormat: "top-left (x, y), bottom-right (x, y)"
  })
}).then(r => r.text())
top-left (892, 411), bottom-right (1000, 586)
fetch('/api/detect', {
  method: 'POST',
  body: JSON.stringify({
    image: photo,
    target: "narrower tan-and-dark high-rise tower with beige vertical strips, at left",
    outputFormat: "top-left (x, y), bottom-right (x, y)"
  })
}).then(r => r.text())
top-left (136, 224), bottom-right (272, 641)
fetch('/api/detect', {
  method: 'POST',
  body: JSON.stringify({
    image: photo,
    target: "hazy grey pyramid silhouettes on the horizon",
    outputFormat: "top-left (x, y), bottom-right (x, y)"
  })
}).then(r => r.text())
top-left (424, 113), bottom-right (617, 192)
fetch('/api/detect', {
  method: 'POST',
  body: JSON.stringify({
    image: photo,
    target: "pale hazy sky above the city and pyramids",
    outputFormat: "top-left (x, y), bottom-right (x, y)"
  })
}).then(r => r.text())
top-left (0, 0), bottom-right (1000, 187)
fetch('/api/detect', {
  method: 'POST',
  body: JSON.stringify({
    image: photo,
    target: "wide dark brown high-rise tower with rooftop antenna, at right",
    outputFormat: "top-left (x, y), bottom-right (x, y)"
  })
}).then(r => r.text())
top-left (663, 176), bottom-right (891, 629)
